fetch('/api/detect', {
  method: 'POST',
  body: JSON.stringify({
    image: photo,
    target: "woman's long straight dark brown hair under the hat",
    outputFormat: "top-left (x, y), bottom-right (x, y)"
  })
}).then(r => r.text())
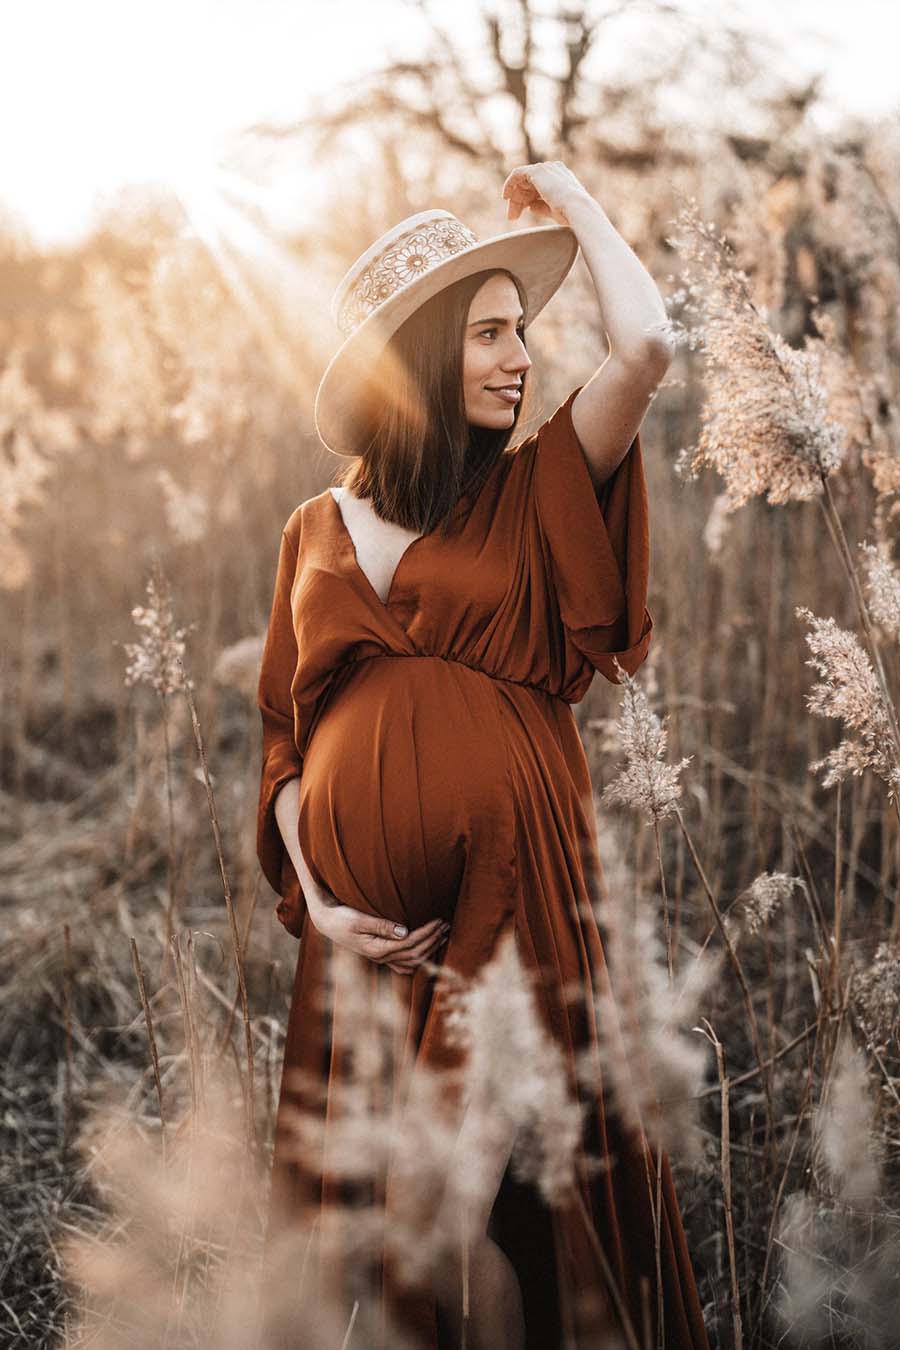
top-left (336, 267), bottom-right (528, 535)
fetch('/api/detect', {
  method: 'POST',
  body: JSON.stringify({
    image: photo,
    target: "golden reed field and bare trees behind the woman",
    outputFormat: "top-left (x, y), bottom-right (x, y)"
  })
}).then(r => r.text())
top-left (0, 4), bottom-right (900, 1347)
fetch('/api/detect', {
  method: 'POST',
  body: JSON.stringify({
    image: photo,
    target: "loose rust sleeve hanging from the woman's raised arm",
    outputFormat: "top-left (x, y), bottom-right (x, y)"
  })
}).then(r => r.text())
top-left (534, 385), bottom-right (653, 684)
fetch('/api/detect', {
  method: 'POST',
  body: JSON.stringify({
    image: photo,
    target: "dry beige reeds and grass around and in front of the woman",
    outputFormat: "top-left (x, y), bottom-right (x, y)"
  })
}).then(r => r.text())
top-left (0, 95), bottom-right (900, 1350)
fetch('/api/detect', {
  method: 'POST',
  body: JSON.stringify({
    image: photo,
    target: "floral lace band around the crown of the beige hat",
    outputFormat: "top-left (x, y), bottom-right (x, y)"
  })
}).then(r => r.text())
top-left (336, 213), bottom-right (478, 336)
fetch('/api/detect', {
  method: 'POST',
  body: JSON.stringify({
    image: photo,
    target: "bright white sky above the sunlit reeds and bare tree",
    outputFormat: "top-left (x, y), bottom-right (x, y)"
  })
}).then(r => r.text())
top-left (0, 0), bottom-right (900, 244)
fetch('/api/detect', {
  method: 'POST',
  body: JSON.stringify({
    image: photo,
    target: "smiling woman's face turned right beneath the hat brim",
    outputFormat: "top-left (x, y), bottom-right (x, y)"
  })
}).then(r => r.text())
top-left (463, 273), bottom-right (532, 431)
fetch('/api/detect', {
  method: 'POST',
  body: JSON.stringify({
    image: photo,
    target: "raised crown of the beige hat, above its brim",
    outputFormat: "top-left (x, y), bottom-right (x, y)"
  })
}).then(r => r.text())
top-left (332, 211), bottom-right (478, 338)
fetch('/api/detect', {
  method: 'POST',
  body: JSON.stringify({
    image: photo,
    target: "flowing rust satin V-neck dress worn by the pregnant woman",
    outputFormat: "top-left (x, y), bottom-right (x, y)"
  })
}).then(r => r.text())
top-left (258, 386), bottom-right (708, 1350)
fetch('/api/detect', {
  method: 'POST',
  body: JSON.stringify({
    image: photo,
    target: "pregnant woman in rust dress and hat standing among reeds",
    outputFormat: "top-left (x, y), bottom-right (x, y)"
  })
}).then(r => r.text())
top-left (258, 162), bottom-right (707, 1350)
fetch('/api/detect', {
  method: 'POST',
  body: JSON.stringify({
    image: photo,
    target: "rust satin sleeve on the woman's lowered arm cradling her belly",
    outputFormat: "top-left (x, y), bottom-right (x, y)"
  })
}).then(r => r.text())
top-left (256, 532), bottom-right (306, 937)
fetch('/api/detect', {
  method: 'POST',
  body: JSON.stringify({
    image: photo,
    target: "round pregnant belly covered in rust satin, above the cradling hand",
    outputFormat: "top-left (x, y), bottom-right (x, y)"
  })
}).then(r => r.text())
top-left (298, 656), bottom-right (513, 927)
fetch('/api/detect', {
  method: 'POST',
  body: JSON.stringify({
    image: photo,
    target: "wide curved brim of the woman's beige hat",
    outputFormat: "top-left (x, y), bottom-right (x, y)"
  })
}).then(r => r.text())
top-left (313, 225), bottom-right (579, 455)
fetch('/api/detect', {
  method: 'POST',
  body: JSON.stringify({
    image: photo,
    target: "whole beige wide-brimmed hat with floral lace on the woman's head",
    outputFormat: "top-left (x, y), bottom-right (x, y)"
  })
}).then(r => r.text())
top-left (314, 209), bottom-right (579, 455)
